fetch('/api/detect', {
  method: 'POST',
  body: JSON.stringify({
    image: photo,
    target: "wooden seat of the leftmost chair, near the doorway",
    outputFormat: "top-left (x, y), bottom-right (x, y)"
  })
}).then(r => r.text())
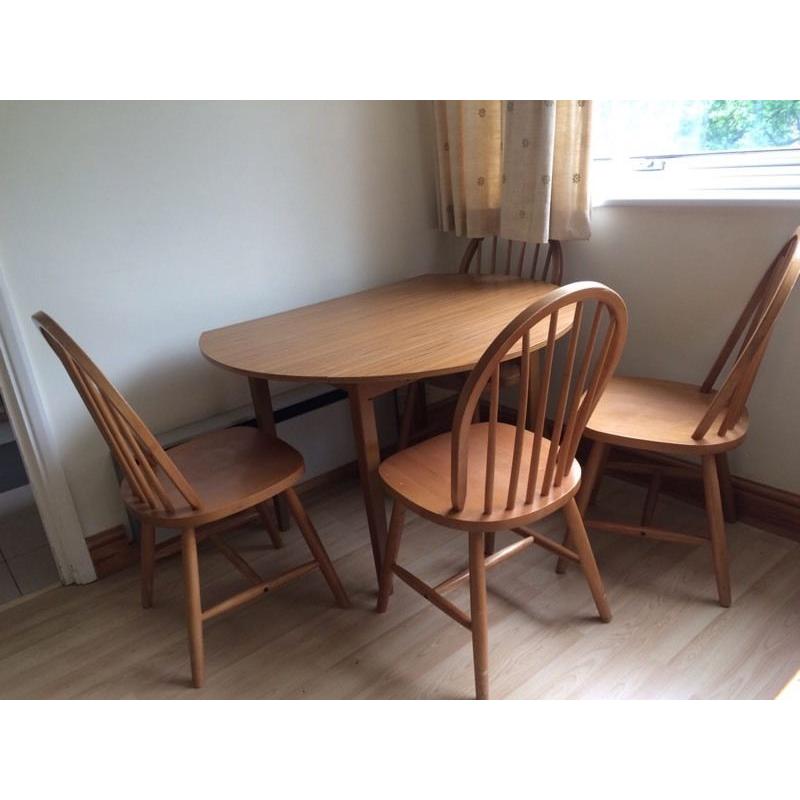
top-left (120, 427), bottom-right (305, 528)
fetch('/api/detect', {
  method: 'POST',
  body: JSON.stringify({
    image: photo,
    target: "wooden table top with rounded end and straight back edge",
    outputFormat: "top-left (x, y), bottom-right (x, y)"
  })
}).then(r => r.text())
top-left (200, 274), bottom-right (574, 384)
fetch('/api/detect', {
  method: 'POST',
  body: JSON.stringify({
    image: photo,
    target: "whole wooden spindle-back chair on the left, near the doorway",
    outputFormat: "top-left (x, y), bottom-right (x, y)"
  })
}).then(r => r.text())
top-left (33, 311), bottom-right (349, 688)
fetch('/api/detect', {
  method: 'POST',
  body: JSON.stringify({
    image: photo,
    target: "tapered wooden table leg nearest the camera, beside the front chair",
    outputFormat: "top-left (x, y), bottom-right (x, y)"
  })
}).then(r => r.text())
top-left (345, 384), bottom-right (391, 583)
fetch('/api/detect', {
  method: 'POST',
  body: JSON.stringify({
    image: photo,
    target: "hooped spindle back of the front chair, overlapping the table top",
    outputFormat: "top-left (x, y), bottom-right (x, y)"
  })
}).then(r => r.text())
top-left (451, 281), bottom-right (628, 514)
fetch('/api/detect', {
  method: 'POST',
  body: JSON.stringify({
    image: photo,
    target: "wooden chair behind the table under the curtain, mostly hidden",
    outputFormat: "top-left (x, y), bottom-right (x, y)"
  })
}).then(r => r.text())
top-left (395, 236), bottom-right (564, 449)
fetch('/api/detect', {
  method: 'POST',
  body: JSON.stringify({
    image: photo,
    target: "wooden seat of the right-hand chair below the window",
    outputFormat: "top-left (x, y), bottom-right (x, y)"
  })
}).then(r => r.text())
top-left (586, 377), bottom-right (748, 455)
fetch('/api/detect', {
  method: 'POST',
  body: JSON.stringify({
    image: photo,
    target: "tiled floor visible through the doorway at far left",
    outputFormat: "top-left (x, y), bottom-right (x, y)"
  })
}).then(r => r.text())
top-left (0, 486), bottom-right (58, 603)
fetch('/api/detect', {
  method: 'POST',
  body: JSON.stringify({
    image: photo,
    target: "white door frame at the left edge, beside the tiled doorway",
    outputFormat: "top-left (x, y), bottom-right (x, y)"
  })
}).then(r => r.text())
top-left (0, 261), bottom-right (97, 584)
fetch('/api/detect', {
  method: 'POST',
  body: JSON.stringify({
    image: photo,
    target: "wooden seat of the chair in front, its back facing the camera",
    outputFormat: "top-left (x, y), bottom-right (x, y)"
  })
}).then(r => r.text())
top-left (380, 422), bottom-right (581, 531)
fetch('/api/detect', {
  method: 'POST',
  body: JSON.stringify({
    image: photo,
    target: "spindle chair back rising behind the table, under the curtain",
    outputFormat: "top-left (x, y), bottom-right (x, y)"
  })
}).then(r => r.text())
top-left (458, 236), bottom-right (564, 286)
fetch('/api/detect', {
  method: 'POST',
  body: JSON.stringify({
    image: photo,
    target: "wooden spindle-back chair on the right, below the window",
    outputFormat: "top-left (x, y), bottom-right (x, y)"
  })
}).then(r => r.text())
top-left (557, 228), bottom-right (800, 607)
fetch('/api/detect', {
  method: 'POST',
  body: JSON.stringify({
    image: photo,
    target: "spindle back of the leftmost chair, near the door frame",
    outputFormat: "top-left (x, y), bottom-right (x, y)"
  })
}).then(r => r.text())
top-left (33, 311), bottom-right (201, 512)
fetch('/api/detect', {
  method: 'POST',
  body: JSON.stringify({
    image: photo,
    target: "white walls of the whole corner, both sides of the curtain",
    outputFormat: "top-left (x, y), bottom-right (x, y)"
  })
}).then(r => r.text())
top-left (0, 102), bottom-right (800, 535)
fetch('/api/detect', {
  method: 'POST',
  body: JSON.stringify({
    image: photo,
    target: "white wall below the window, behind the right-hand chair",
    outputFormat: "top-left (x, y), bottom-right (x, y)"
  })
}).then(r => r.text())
top-left (565, 204), bottom-right (800, 492)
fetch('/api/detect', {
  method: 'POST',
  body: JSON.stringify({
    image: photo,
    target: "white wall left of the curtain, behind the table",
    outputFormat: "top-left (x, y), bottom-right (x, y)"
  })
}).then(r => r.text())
top-left (0, 102), bottom-right (450, 536)
